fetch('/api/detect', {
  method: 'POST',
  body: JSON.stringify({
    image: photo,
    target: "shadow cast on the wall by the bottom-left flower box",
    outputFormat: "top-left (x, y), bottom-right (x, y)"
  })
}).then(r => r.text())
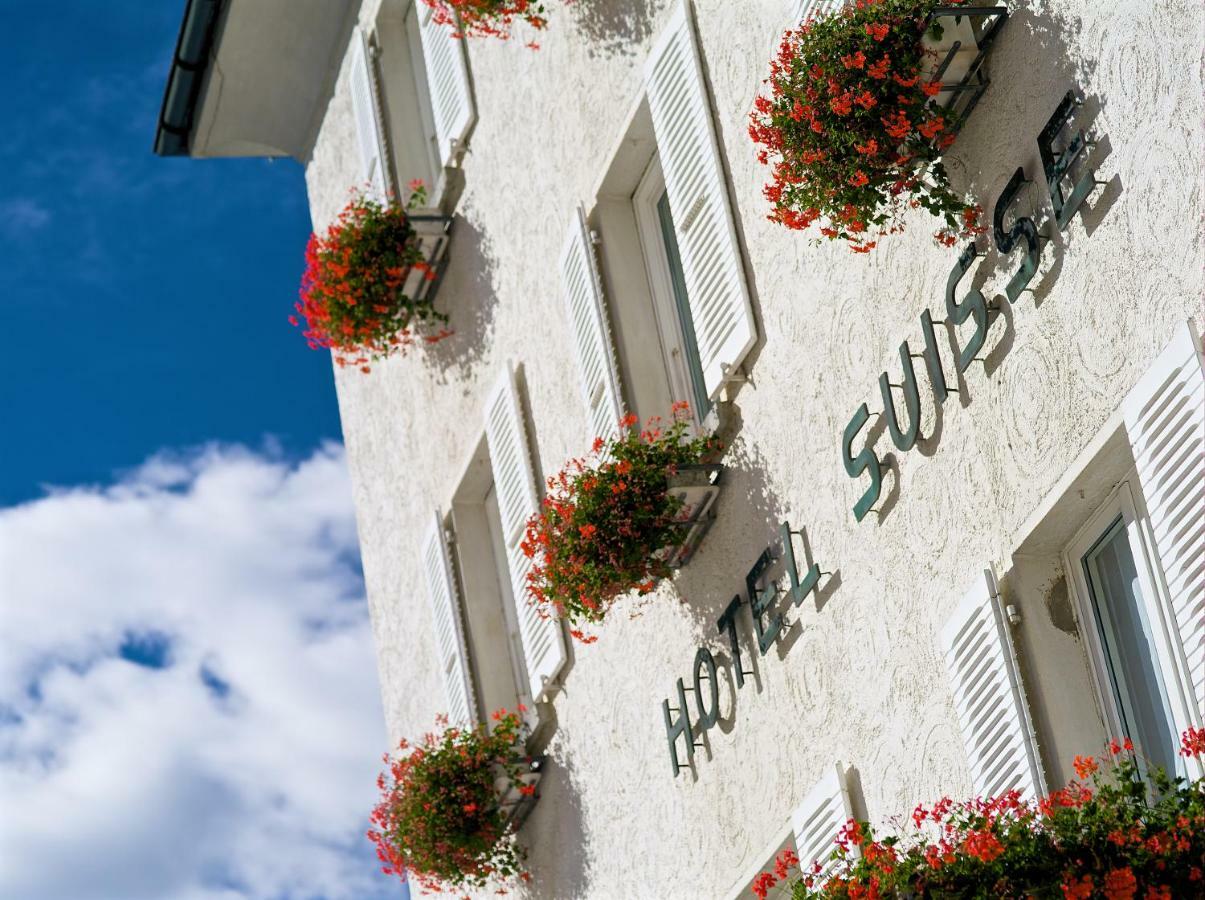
top-left (519, 754), bottom-right (590, 900)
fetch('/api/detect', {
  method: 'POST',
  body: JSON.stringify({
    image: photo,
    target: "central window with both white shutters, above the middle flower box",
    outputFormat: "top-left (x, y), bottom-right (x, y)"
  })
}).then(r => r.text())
top-left (562, 0), bottom-right (757, 443)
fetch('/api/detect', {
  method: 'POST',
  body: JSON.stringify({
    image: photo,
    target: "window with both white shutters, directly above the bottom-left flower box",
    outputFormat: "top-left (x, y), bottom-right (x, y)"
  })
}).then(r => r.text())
top-left (424, 369), bottom-right (568, 723)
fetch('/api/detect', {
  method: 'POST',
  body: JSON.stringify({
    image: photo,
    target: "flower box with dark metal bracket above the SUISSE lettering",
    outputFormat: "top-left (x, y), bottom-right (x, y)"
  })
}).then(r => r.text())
top-left (922, 6), bottom-right (1009, 125)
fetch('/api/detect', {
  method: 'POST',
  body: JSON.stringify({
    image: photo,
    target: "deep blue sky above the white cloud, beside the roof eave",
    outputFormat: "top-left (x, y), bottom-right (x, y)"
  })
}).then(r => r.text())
top-left (0, 0), bottom-right (340, 502)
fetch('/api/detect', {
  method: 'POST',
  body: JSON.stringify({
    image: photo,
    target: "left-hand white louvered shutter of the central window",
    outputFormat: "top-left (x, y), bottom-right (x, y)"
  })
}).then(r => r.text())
top-left (560, 207), bottom-right (623, 437)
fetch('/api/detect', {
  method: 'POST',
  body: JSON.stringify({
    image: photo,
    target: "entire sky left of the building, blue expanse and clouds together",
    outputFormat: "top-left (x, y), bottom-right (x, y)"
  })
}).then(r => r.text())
top-left (0, 0), bottom-right (401, 900)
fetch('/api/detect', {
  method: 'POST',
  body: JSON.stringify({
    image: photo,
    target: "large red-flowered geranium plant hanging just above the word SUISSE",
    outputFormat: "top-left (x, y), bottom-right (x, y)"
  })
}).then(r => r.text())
top-left (750, 0), bottom-right (983, 253)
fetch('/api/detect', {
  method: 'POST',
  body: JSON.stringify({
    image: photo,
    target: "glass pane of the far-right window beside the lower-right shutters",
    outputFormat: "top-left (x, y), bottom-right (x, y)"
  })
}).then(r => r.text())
top-left (1083, 519), bottom-right (1180, 772)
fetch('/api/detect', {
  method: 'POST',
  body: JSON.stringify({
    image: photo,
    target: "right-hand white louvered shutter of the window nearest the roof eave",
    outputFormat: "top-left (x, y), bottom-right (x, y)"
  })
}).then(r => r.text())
top-left (418, 4), bottom-right (477, 166)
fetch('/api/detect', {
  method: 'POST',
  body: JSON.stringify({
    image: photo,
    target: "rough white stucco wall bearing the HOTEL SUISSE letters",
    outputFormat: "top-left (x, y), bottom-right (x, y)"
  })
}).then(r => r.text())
top-left (307, 0), bottom-right (1205, 898)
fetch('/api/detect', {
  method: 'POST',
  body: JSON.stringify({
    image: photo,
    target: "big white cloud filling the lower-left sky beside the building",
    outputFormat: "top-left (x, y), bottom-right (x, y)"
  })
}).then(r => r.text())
top-left (0, 446), bottom-right (400, 900)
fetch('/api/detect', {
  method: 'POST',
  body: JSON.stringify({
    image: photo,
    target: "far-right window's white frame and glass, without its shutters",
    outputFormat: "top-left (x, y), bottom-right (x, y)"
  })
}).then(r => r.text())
top-left (1064, 482), bottom-right (1183, 772)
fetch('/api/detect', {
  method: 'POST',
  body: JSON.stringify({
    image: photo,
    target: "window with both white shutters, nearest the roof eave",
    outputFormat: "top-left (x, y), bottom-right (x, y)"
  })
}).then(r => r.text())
top-left (349, 0), bottom-right (476, 207)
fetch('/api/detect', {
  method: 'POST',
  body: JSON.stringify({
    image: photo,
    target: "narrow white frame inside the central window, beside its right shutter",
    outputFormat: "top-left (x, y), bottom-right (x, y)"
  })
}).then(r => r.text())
top-left (631, 153), bottom-right (715, 428)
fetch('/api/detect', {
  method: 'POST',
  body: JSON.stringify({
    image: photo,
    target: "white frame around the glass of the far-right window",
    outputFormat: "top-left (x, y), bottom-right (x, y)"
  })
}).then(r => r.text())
top-left (1062, 479), bottom-right (1187, 775)
